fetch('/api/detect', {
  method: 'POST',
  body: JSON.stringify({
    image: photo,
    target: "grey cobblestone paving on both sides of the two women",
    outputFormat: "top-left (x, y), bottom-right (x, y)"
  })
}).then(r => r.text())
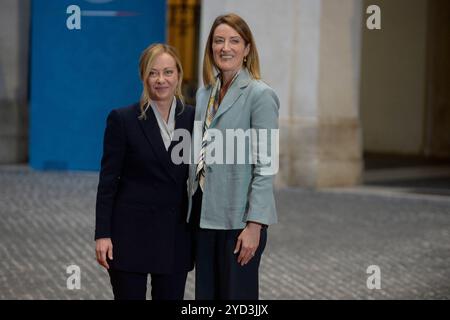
top-left (0, 166), bottom-right (450, 300)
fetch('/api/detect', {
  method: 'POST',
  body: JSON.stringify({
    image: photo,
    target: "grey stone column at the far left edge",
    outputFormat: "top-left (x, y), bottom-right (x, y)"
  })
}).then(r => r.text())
top-left (0, 0), bottom-right (30, 163)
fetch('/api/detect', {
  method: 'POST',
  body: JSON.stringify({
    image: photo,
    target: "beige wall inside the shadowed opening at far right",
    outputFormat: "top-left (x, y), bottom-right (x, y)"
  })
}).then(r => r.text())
top-left (361, 0), bottom-right (427, 154)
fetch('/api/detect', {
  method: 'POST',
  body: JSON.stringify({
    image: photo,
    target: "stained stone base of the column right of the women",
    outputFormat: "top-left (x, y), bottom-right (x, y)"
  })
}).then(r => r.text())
top-left (275, 118), bottom-right (363, 188)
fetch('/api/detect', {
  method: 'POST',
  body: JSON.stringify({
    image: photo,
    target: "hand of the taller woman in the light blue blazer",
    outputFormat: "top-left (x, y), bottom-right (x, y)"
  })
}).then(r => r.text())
top-left (234, 222), bottom-right (262, 266)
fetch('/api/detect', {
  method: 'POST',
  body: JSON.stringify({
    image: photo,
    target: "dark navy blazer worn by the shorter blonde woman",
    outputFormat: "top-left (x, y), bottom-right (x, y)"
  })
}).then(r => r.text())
top-left (95, 101), bottom-right (194, 274)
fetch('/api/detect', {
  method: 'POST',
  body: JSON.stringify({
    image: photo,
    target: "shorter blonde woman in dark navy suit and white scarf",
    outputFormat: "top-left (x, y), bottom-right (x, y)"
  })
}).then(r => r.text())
top-left (95, 44), bottom-right (194, 300)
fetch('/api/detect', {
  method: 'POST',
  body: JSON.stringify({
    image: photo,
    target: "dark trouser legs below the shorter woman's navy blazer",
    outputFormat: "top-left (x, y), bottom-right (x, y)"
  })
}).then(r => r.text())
top-left (108, 269), bottom-right (187, 300)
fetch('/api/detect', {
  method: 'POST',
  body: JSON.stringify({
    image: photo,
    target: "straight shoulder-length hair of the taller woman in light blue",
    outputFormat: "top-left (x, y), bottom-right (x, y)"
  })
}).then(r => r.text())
top-left (203, 13), bottom-right (261, 86)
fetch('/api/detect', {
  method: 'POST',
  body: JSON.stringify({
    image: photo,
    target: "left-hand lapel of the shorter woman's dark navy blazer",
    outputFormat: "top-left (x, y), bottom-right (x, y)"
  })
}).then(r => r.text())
top-left (138, 103), bottom-right (178, 180)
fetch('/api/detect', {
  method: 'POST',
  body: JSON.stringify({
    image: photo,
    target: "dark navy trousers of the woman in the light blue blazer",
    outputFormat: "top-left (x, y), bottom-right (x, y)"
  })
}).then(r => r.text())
top-left (191, 188), bottom-right (267, 300)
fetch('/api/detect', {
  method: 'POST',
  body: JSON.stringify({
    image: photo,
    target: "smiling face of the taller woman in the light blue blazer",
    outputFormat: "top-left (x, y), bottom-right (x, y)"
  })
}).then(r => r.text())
top-left (212, 23), bottom-right (250, 73)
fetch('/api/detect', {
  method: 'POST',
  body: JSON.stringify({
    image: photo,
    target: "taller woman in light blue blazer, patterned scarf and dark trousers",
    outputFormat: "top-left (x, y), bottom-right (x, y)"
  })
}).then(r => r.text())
top-left (188, 14), bottom-right (279, 300)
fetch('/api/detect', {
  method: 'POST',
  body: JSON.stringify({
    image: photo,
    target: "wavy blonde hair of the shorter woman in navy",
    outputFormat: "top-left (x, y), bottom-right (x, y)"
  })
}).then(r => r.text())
top-left (139, 43), bottom-right (184, 120)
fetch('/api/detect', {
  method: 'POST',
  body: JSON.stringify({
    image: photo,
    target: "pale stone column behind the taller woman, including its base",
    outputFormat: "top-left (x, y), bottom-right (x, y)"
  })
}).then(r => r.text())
top-left (200, 0), bottom-right (363, 188)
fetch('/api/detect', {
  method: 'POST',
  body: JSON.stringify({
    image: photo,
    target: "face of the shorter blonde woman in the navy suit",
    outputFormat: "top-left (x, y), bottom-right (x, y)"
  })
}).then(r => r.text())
top-left (147, 52), bottom-right (178, 102)
